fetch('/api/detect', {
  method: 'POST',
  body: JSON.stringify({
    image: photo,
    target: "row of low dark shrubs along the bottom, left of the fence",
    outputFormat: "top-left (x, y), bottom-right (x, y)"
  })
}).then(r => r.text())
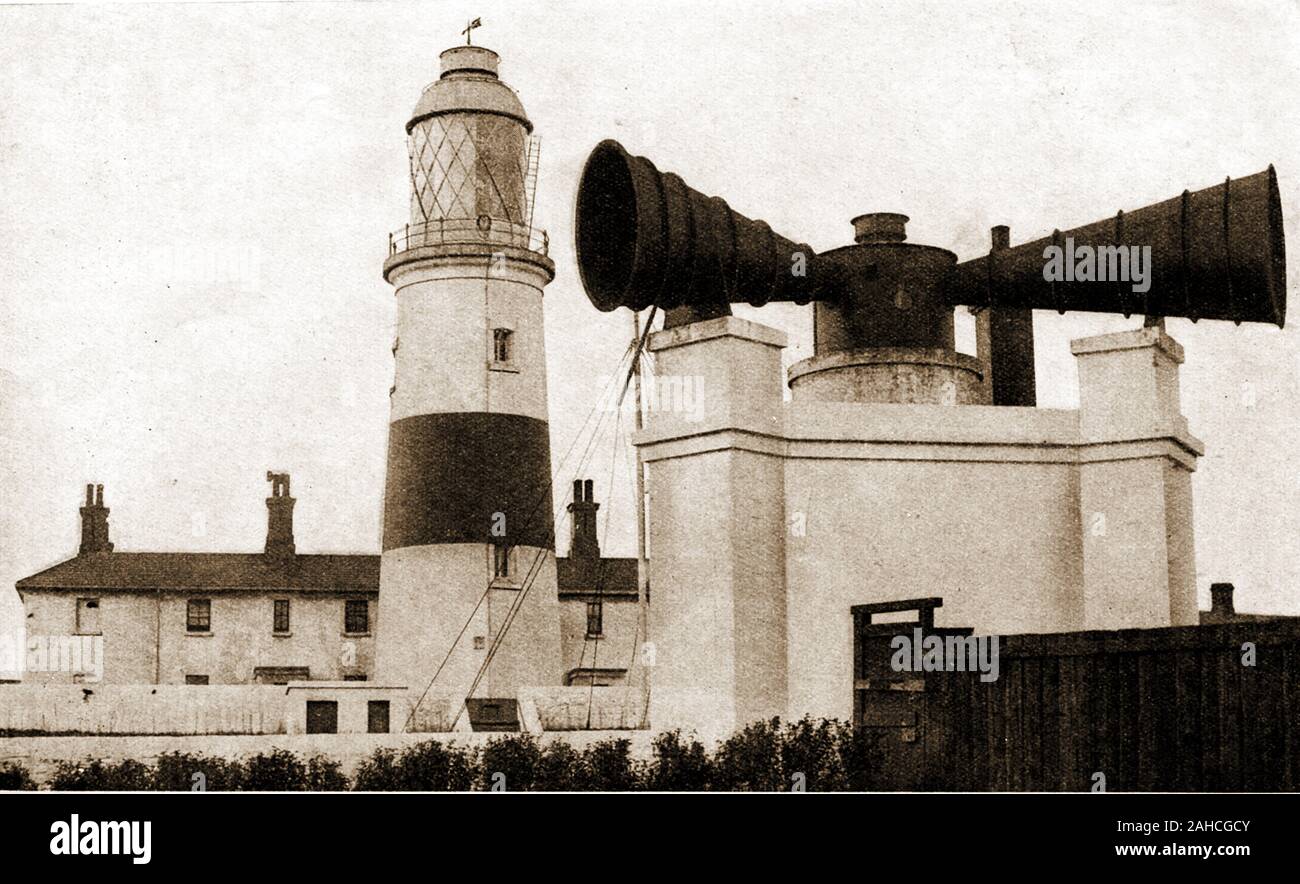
top-left (0, 718), bottom-right (880, 792)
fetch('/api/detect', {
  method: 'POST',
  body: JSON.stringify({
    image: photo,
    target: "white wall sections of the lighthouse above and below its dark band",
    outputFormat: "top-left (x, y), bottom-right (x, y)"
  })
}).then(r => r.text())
top-left (376, 246), bottom-right (560, 697)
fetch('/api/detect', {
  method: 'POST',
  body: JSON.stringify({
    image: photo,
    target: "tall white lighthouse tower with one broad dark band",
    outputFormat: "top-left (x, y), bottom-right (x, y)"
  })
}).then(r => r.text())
top-left (376, 46), bottom-right (560, 728)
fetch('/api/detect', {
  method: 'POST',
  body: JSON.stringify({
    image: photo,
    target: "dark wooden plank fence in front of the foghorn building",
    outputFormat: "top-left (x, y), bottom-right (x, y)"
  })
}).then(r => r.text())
top-left (854, 599), bottom-right (1300, 792)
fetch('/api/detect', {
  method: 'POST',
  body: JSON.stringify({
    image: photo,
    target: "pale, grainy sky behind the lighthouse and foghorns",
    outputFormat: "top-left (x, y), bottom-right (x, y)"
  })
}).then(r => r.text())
top-left (0, 0), bottom-right (1300, 652)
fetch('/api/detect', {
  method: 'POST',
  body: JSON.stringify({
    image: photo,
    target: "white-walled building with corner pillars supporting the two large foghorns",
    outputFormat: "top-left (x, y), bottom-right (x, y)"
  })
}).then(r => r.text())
top-left (636, 317), bottom-right (1203, 736)
